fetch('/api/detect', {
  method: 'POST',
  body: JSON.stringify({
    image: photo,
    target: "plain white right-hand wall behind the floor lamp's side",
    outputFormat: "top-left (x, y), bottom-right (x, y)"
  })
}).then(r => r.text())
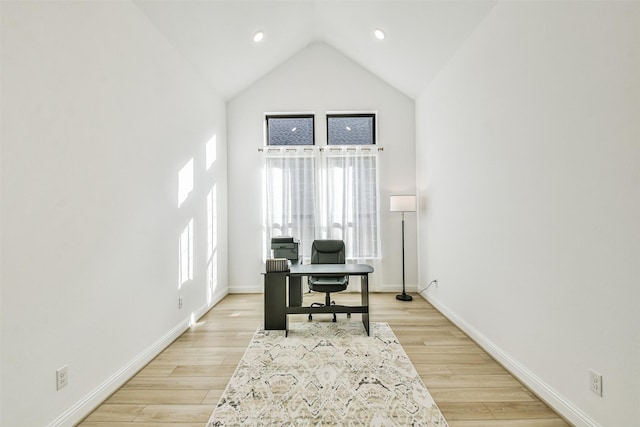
top-left (416, 2), bottom-right (640, 426)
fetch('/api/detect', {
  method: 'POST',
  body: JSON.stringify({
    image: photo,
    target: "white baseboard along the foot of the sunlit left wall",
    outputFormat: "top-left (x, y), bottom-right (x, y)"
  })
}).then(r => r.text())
top-left (47, 293), bottom-right (227, 427)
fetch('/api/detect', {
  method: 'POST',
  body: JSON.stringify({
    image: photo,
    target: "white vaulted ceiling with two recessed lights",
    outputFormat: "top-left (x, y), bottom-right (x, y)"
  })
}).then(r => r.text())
top-left (134, 0), bottom-right (496, 100)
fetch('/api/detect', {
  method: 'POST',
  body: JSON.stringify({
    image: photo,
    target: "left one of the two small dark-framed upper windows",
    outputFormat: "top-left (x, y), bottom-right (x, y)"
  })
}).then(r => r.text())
top-left (267, 114), bottom-right (315, 145)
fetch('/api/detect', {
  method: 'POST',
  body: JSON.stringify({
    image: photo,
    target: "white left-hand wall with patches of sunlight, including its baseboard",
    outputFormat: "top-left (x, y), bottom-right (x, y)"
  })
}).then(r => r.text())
top-left (0, 2), bottom-right (227, 427)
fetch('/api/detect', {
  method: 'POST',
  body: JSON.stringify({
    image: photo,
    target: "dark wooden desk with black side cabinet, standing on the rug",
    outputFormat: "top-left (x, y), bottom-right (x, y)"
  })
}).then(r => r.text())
top-left (264, 263), bottom-right (373, 335)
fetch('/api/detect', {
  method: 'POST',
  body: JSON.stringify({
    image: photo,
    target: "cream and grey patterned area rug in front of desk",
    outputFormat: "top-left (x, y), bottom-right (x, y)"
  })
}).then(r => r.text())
top-left (207, 321), bottom-right (447, 427)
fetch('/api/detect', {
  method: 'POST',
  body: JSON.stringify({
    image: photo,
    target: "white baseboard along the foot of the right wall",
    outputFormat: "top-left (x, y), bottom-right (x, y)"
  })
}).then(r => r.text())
top-left (420, 293), bottom-right (601, 427)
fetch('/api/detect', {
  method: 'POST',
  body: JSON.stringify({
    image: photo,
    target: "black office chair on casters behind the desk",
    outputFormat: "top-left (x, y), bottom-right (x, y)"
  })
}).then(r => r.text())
top-left (309, 240), bottom-right (351, 322)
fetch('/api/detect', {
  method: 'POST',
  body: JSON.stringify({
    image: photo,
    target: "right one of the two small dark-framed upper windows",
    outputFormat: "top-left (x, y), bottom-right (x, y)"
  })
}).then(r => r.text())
top-left (327, 114), bottom-right (376, 145)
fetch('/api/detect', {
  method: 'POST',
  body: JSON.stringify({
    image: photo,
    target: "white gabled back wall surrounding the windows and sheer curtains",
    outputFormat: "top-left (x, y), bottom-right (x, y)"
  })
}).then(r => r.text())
top-left (227, 42), bottom-right (417, 292)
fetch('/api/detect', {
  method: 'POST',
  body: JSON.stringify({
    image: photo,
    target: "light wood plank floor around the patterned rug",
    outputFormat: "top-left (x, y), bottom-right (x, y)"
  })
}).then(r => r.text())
top-left (79, 293), bottom-right (569, 427)
